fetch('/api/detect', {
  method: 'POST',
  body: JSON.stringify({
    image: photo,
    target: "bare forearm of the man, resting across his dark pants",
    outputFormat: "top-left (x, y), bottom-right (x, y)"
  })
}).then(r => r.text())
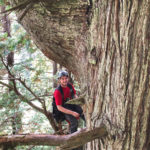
top-left (57, 105), bottom-right (80, 118)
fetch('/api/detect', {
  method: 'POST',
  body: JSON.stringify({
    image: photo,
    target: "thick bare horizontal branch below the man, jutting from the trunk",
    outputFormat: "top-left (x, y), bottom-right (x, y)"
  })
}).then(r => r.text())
top-left (0, 125), bottom-right (107, 150)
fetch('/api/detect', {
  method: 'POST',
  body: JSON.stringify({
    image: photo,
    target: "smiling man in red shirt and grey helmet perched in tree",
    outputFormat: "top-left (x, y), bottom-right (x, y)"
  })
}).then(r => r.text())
top-left (53, 71), bottom-right (85, 133)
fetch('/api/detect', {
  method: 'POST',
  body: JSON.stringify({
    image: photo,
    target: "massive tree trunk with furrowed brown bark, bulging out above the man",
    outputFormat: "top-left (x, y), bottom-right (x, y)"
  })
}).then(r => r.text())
top-left (6, 0), bottom-right (150, 150)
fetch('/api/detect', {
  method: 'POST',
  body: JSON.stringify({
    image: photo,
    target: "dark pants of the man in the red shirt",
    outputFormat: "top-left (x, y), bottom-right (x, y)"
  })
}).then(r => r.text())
top-left (64, 104), bottom-right (85, 150)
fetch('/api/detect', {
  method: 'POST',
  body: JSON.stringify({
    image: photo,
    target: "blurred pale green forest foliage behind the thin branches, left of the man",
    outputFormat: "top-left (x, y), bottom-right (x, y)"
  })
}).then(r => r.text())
top-left (0, 15), bottom-right (52, 137)
